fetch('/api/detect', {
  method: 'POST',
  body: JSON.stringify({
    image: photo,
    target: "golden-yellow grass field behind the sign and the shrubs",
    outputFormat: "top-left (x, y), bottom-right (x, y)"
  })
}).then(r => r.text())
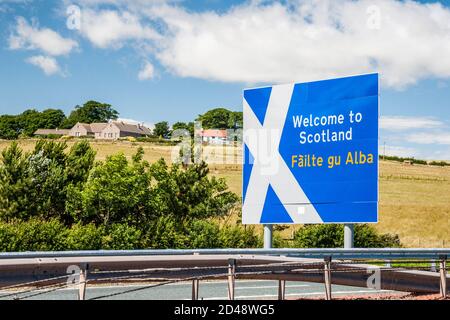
top-left (0, 140), bottom-right (450, 247)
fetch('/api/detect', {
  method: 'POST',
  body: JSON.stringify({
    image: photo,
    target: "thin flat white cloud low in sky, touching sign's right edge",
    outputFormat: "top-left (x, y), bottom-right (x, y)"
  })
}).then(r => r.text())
top-left (380, 116), bottom-right (444, 131)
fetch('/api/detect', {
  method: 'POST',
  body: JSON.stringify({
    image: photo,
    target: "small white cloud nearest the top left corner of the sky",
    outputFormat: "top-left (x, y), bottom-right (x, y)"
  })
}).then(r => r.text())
top-left (9, 17), bottom-right (78, 56)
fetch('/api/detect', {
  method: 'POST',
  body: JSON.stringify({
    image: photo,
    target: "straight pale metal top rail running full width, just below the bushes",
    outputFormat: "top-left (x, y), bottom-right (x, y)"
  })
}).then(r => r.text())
top-left (0, 248), bottom-right (450, 264)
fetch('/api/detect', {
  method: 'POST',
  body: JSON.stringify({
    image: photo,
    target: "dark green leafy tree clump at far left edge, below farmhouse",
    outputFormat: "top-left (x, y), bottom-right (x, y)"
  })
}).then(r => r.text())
top-left (0, 140), bottom-right (95, 224)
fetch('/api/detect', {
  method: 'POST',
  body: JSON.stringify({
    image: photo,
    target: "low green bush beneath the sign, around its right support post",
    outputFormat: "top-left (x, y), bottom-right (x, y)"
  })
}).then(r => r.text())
top-left (294, 224), bottom-right (401, 248)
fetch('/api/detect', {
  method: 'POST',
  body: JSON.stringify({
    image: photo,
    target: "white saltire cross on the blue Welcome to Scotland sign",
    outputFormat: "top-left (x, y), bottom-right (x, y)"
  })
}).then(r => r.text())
top-left (242, 84), bottom-right (323, 224)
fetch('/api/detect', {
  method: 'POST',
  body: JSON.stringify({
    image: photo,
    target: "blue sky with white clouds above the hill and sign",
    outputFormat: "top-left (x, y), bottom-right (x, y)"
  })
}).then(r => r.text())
top-left (0, 0), bottom-right (450, 160)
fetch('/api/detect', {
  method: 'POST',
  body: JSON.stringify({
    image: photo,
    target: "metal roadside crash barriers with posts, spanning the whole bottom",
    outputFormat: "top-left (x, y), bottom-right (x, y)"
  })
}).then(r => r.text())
top-left (0, 248), bottom-right (450, 300)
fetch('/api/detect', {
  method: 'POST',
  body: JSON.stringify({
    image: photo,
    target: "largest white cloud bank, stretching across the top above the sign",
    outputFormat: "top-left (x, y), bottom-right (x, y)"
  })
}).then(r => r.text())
top-left (71, 0), bottom-right (450, 88)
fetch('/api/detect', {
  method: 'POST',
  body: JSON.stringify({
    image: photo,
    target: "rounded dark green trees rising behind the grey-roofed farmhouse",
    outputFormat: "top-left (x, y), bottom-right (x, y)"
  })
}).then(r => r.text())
top-left (64, 100), bottom-right (119, 128)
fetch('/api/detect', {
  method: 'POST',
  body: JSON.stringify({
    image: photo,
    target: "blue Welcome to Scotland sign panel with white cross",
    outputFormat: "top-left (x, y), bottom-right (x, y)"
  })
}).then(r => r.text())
top-left (242, 74), bottom-right (379, 224)
